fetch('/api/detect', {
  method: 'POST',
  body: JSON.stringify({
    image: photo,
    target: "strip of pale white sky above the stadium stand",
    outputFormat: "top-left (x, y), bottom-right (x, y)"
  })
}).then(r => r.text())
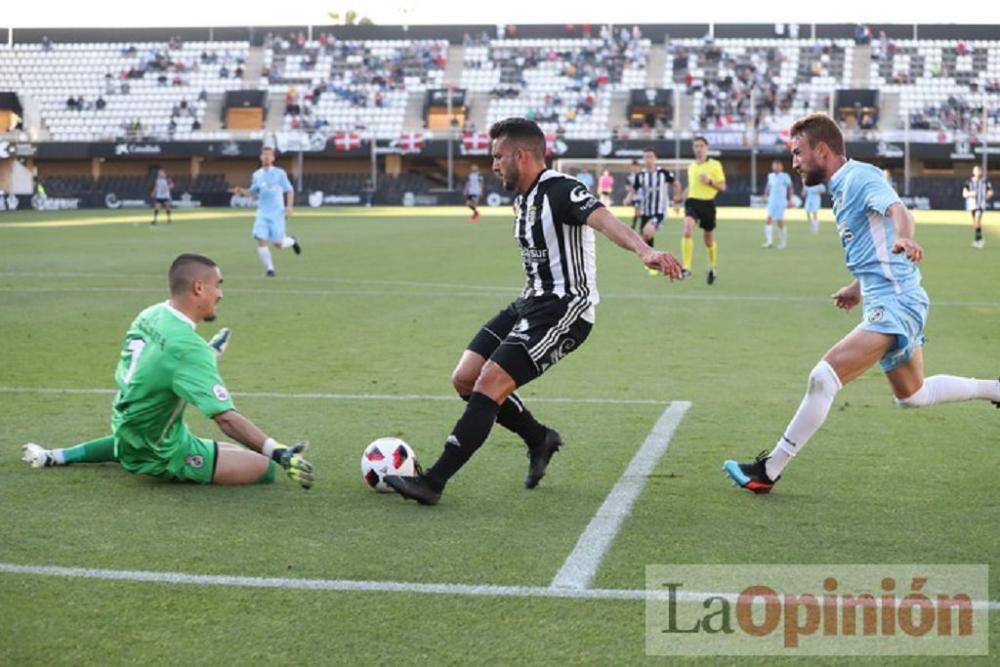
top-left (0, 0), bottom-right (1000, 29)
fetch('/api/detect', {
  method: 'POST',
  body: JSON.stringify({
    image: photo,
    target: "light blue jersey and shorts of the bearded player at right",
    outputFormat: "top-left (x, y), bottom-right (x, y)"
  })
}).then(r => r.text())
top-left (829, 160), bottom-right (930, 372)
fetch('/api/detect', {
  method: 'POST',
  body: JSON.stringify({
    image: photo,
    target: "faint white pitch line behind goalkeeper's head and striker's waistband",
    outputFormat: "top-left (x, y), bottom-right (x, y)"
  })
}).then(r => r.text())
top-left (0, 283), bottom-right (1000, 308)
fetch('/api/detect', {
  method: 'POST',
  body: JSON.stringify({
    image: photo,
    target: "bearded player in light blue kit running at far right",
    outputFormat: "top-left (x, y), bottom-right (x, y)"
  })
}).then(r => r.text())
top-left (723, 114), bottom-right (1000, 493)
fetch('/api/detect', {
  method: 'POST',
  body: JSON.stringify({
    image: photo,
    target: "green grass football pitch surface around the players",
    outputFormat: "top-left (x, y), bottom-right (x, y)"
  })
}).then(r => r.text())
top-left (0, 209), bottom-right (1000, 665)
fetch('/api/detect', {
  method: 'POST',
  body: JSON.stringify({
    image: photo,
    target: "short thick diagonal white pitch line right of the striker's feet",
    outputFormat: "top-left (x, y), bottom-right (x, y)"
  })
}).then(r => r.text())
top-left (552, 401), bottom-right (691, 590)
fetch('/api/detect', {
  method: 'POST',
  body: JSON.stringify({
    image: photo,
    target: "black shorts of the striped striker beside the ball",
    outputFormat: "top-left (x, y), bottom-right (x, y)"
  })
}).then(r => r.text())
top-left (466, 296), bottom-right (593, 387)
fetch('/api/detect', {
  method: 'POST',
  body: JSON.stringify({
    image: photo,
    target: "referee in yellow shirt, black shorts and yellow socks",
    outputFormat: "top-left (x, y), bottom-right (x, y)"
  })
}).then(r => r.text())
top-left (681, 137), bottom-right (726, 285)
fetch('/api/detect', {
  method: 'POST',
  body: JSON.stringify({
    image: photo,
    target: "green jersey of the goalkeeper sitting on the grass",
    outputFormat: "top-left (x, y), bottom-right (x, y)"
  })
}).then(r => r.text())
top-left (111, 303), bottom-right (233, 461)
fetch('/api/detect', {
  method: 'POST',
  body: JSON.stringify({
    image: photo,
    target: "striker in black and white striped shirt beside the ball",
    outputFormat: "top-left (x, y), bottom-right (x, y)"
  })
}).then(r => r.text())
top-left (385, 118), bottom-right (682, 505)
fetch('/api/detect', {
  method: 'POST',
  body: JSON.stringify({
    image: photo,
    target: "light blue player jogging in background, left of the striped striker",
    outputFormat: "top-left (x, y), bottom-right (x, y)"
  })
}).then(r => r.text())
top-left (236, 146), bottom-right (302, 278)
